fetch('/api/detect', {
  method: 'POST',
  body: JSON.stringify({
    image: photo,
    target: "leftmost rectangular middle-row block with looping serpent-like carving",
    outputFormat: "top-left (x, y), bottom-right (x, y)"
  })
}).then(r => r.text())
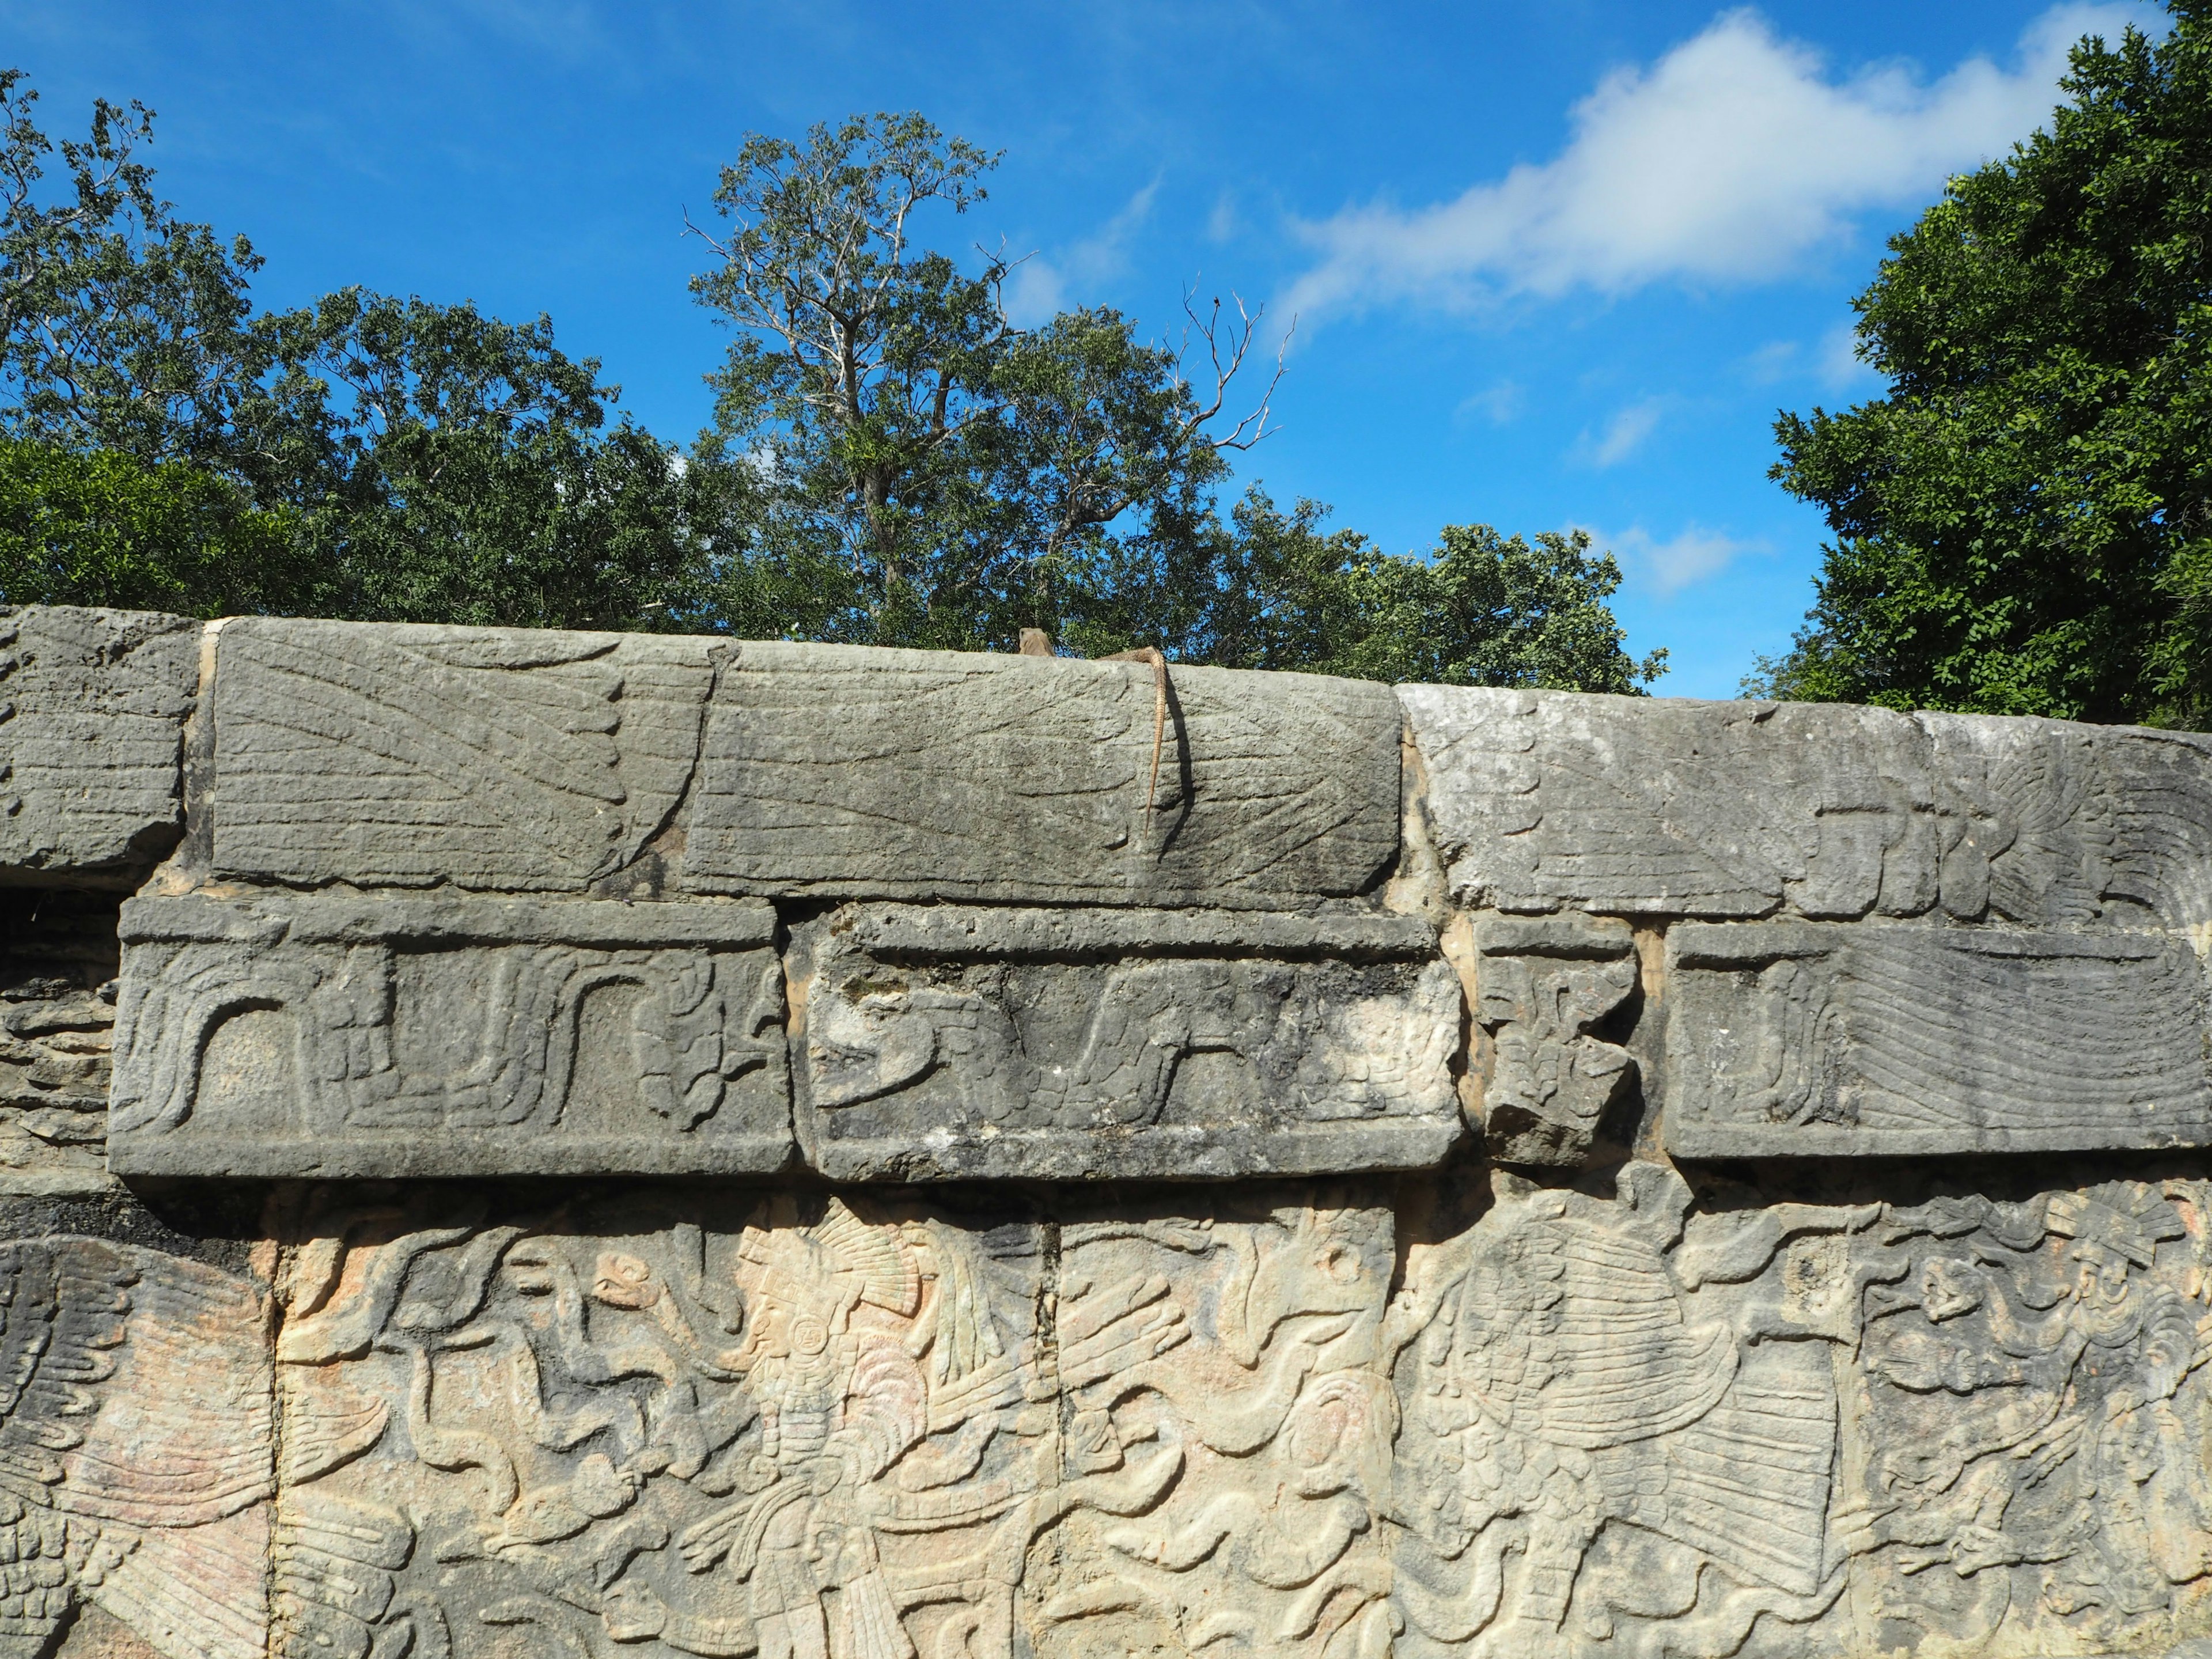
top-left (108, 893), bottom-right (792, 1175)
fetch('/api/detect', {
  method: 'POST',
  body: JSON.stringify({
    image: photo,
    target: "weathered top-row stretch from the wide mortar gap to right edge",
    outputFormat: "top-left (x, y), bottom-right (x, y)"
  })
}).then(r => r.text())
top-left (1400, 685), bottom-right (2212, 929)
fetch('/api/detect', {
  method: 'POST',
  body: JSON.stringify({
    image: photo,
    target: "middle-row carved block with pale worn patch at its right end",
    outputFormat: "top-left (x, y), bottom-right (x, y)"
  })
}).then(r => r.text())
top-left (798, 907), bottom-right (1460, 1179)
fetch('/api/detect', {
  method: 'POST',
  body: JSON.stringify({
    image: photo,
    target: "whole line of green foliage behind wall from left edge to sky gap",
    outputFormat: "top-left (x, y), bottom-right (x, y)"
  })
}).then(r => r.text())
top-left (0, 73), bottom-right (1664, 690)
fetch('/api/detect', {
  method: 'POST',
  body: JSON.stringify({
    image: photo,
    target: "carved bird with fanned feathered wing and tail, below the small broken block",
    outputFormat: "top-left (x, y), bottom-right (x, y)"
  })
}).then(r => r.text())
top-left (1389, 1164), bottom-right (1867, 1654)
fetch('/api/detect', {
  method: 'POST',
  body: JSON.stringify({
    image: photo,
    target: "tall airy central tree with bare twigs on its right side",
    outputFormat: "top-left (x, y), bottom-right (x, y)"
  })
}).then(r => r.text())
top-left (692, 115), bottom-right (1265, 650)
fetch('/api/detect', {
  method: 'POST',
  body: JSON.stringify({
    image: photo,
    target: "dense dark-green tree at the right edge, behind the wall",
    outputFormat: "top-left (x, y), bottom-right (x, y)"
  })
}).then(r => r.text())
top-left (1745, 0), bottom-right (2212, 724)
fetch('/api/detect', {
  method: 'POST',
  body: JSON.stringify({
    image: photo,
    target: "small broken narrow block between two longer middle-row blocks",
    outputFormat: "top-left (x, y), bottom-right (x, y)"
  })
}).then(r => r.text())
top-left (1475, 914), bottom-right (1637, 1168)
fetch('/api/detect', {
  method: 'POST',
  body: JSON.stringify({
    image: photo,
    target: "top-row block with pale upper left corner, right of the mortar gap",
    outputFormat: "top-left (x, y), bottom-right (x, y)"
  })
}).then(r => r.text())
top-left (1400, 685), bottom-right (1986, 918)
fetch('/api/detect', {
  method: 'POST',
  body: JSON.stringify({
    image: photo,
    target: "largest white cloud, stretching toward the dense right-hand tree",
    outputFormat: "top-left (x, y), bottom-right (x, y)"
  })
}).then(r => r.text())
top-left (1285, 5), bottom-right (2154, 314)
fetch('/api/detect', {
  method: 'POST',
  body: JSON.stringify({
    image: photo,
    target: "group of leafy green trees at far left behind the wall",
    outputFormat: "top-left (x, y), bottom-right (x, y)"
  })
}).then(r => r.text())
top-left (0, 71), bottom-right (699, 628)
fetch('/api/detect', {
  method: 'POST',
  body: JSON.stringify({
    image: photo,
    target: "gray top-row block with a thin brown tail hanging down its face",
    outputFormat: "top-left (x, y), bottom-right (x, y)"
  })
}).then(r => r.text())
top-left (685, 643), bottom-right (1403, 909)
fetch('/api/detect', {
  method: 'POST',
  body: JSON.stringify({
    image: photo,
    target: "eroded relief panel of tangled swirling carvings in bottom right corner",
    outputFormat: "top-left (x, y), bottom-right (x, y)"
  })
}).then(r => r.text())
top-left (1838, 1181), bottom-right (2212, 1652)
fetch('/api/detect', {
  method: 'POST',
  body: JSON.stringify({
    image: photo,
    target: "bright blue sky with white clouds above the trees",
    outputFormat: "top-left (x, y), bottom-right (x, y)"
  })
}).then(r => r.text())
top-left (0, 0), bottom-right (2154, 697)
